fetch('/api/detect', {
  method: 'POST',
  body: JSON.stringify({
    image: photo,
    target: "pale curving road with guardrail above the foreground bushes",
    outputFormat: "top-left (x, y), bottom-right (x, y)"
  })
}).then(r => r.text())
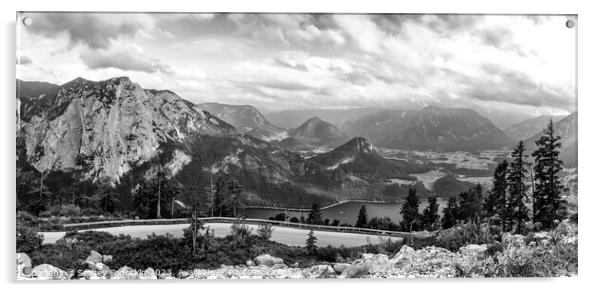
top-left (41, 223), bottom-right (399, 247)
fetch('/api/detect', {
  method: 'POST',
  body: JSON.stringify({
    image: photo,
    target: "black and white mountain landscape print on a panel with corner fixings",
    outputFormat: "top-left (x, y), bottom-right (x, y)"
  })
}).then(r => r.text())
top-left (16, 13), bottom-right (578, 280)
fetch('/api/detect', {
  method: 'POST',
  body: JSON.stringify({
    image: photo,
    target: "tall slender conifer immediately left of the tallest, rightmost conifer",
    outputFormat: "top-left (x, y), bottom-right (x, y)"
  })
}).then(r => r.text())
top-left (507, 141), bottom-right (529, 233)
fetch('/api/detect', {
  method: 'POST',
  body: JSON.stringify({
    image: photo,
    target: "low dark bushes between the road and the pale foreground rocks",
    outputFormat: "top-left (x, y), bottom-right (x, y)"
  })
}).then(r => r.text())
top-left (17, 223), bottom-right (578, 277)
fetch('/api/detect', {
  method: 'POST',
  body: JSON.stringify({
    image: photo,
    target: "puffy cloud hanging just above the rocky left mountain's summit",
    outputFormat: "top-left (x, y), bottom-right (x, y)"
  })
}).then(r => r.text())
top-left (80, 46), bottom-right (172, 74)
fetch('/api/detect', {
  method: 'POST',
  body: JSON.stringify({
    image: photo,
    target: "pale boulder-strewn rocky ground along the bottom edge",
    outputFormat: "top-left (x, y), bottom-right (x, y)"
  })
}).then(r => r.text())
top-left (17, 225), bottom-right (577, 280)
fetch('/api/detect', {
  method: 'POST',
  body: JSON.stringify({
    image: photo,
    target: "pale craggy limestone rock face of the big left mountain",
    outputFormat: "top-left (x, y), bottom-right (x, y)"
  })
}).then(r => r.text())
top-left (18, 77), bottom-right (235, 181)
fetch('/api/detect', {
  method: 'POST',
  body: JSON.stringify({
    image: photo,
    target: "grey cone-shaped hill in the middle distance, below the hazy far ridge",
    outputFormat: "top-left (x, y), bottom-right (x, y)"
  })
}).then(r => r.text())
top-left (279, 117), bottom-right (349, 149)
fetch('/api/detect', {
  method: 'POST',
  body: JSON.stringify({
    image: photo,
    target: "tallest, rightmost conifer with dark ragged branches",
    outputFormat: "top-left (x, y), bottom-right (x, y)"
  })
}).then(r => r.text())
top-left (531, 120), bottom-right (567, 228)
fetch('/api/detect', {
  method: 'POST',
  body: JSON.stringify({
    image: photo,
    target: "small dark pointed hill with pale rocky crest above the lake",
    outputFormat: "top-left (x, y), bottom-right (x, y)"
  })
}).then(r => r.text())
top-left (308, 137), bottom-right (410, 179)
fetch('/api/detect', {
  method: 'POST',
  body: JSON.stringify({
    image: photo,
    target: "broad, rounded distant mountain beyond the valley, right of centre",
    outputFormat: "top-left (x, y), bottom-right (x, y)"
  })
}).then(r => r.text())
top-left (344, 106), bottom-right (512, 151)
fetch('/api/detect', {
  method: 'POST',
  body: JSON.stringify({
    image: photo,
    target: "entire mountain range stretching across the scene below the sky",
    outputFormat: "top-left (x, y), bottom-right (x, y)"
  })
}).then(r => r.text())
top-left (16, 77), bottom-right (576, 207)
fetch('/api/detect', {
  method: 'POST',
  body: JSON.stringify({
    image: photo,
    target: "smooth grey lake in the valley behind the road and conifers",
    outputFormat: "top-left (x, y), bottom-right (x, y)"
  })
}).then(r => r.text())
top-left (245, 198), bottom-right (447, 225)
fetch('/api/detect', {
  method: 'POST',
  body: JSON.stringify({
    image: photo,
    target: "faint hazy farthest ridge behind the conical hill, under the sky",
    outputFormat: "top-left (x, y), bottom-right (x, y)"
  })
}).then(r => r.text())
top-left (265, 108), bottom-right (383, 129)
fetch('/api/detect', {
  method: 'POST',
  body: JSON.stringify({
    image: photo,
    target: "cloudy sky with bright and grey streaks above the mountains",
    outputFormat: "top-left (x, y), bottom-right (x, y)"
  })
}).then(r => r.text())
top-left (17, 13), bottom-right (576, 126)
